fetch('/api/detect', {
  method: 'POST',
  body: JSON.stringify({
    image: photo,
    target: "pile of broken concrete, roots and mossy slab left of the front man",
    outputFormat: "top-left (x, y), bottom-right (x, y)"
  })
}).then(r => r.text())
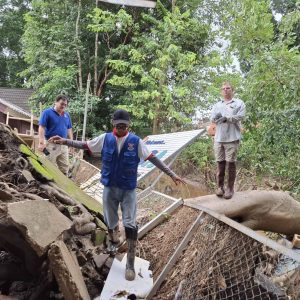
top-left (0, 123), bottom-right (112, 300)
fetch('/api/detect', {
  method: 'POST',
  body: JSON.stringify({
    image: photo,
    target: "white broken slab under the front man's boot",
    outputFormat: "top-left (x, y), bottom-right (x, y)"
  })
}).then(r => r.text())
top-left (95, 255), bottom-right (153, 300)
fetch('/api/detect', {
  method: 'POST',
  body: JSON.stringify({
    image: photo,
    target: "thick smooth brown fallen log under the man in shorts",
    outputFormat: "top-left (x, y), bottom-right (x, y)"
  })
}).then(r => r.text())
top-left (184, 190), bottom-right (300, 235)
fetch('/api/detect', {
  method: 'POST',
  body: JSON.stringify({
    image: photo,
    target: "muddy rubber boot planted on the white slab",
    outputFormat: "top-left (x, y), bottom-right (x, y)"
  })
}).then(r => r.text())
top-left (125, 227), bottom-right (137, 281)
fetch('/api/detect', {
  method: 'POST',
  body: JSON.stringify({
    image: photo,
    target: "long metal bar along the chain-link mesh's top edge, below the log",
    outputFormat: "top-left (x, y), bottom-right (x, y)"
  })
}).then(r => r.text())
top-left (184, 203), bottom-right (300, 262)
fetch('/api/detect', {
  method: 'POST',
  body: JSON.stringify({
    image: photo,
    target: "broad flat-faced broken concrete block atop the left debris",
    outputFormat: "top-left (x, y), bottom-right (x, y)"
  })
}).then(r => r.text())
top-left (7, 200), bottom-right (72, 256)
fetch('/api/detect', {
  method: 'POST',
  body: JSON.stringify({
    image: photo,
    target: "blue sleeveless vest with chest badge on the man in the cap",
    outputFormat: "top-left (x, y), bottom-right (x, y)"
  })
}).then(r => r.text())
top-left (101, 133), bottom-right (140, 190)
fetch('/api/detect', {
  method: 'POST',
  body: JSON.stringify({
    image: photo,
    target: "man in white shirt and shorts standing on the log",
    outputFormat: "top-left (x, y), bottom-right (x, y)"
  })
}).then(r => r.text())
top-left (211, 82), bottom-right (246, 199)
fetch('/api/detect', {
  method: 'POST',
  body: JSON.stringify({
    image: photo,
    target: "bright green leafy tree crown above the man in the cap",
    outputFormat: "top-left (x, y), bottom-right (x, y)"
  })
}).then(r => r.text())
top-left (90, 1), bottom-right (207, 132)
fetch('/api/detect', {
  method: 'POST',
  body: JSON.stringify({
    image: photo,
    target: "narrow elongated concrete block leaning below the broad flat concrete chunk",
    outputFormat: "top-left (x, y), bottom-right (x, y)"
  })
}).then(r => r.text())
top-left (48, 241), bottom-right (90, 300)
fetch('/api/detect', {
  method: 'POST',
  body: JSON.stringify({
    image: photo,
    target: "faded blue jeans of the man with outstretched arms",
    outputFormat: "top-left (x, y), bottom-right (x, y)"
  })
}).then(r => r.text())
top-left (103, 186), bottom-right (136, 229)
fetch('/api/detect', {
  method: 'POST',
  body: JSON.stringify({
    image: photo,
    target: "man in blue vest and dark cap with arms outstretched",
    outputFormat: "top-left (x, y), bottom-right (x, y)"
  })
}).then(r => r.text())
top-left (50, 109), bottom-right (184, 280)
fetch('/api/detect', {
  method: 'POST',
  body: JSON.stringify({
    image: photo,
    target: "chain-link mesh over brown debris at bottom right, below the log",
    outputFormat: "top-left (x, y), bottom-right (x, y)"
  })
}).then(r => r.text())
top-left (178, 215), bottom-right (300, 300)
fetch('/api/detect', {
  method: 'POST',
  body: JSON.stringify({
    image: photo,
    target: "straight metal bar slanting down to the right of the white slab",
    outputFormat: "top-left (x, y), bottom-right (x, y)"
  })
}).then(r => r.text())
top-left (146, 212), bottom-right (203, 300)
